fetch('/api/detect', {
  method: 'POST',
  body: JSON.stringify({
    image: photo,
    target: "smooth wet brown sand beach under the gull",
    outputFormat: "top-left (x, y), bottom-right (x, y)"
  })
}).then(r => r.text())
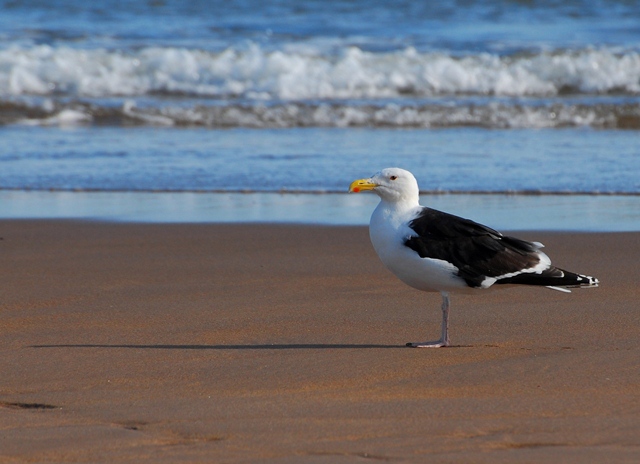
top-left (0, 221), bottom-right (640, 463)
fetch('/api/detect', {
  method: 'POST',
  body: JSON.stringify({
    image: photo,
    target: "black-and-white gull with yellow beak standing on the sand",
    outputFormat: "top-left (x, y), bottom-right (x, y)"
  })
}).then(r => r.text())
top-left (349, 168), bottom-right (599, 348)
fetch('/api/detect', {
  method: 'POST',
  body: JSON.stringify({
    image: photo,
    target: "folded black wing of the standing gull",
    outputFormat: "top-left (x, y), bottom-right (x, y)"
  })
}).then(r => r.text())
top-left (405, 208), bottom-right (544, 287)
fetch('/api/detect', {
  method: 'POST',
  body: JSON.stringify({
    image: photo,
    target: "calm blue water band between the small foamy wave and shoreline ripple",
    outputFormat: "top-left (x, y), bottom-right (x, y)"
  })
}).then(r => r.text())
top-left (0, 126), bottom-right (640, 194)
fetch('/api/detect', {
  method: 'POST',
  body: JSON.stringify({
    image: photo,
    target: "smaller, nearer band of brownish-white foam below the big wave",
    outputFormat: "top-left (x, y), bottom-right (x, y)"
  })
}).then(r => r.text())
top-left (6, 99), bottom-right (640, 129)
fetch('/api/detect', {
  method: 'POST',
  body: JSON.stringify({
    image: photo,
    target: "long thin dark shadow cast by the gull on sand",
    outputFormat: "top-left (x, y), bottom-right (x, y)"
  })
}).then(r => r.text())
top-left (30, 343), bottom-right (469, 350)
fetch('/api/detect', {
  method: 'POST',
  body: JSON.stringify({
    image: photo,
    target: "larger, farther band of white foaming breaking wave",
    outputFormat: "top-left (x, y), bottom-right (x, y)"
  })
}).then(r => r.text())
top-left (0, 44), bottom-right (640, 100)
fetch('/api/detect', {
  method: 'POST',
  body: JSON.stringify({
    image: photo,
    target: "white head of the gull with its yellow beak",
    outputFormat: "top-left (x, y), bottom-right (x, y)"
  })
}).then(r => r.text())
top-left (349, 168), bottom-right (419, 204)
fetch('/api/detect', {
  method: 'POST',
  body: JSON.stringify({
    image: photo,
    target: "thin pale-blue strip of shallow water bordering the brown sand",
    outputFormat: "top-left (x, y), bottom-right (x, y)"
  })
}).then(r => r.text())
top-left (0, 190), bottom-right (640, 232)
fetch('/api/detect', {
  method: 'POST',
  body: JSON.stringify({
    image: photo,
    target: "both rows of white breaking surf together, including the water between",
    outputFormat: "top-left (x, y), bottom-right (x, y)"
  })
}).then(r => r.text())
top-left (0, 44), bottom-right (640, 129)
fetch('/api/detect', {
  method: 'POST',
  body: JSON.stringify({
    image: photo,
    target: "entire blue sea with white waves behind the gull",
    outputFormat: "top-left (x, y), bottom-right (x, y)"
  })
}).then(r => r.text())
top-left (0, 0), bottom-right (640, 230)
